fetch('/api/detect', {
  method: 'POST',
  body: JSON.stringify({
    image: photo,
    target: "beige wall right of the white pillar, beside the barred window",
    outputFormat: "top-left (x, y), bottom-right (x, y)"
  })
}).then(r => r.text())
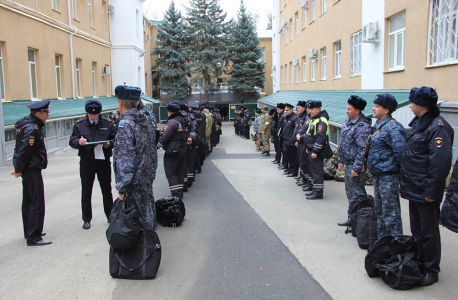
top-left (384, 0), bottom-right (458, 101)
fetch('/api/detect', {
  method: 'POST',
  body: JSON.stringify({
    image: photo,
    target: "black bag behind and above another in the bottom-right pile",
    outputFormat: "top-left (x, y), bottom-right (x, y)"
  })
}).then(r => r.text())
top-left (364, 234), bottom-right (418, 277)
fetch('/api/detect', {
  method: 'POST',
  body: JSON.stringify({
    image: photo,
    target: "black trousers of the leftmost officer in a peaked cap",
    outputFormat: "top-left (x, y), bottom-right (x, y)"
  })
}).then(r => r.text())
top-left (22, 171), bottom-right (45, 244)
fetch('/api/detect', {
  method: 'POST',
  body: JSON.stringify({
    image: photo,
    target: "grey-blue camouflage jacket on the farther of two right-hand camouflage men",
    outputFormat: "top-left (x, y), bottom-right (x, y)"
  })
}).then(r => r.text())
top-left (339, 114), bottom-right (371, 174)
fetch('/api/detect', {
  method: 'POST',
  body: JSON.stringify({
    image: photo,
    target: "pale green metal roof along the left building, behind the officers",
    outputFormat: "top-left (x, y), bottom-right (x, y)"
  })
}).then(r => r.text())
top-left (2, 95), bottom-right (160, 126)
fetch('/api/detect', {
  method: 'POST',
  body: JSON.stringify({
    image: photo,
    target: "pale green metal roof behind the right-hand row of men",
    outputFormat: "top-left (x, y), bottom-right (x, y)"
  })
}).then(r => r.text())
top-left (258, 89), bottom-right (410, 124)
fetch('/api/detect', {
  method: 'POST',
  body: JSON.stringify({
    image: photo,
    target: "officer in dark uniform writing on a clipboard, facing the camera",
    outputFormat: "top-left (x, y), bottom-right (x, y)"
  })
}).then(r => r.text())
top-left (69, 99), bottom-right (116, 229)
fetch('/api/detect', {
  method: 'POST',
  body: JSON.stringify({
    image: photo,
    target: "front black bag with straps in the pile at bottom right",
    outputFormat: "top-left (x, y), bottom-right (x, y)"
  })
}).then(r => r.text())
top-left (374, 252), bottom-right (422, 290)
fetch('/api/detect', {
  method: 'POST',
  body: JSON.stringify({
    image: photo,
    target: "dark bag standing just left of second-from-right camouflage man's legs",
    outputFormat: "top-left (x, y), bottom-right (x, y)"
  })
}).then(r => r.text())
top-left (353, 207), bottom-right (377, 249)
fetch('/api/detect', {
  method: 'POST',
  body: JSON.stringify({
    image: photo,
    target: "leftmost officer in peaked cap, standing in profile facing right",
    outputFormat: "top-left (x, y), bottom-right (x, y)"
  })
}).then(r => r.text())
top-left (11, 99), bottom-right (52, 246)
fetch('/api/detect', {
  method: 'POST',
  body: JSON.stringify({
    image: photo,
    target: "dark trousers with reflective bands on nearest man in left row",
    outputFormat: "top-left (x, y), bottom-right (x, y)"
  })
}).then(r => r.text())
top-left (164, 147), bottom-right (186, 199)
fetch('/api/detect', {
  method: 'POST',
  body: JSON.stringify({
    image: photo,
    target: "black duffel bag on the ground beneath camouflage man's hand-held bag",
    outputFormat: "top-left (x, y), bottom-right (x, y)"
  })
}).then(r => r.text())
top-left (110, 221), bottom-right (162, 279)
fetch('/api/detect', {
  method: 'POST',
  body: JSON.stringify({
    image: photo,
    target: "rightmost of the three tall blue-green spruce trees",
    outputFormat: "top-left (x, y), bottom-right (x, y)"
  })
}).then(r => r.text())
top-left (228, 0), bottom-right (266, 98)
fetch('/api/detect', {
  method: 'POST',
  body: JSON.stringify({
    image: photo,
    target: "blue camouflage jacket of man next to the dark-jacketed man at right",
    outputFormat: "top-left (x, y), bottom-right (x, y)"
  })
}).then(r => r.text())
top-left (367, 115), bottom-right (406, 176)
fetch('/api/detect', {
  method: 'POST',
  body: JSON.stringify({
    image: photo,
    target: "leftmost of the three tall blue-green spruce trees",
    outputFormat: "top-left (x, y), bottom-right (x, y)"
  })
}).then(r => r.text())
top-left (151, 1), bottom-right (188, 100)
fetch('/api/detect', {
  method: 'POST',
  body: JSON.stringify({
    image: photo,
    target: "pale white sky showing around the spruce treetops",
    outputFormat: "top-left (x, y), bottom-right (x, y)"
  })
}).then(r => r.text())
top-left (143, 0), bottom-right (273, 29)
